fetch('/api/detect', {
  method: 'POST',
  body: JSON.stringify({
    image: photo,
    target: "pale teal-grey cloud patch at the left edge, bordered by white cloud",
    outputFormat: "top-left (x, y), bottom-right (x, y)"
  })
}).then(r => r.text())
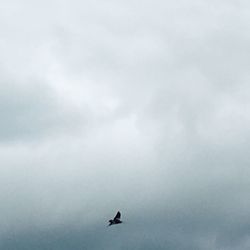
top-left (0, 79), bottom-right (87, 143)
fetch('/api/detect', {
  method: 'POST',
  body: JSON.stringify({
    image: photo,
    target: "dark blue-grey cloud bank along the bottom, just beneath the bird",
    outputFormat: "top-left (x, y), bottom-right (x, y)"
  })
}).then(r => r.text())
top-left (1, 211), bottom-right (249, 249)
